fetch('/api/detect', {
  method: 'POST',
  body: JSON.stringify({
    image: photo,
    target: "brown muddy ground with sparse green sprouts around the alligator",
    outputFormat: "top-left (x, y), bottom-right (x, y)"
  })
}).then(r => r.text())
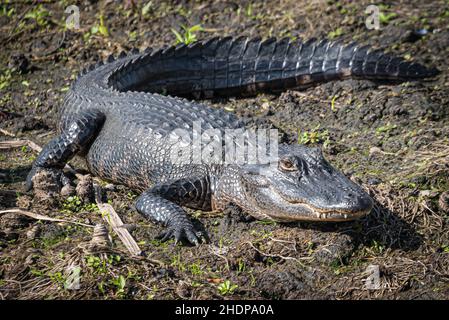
top-left (0, 0), bottom-right (449, 299)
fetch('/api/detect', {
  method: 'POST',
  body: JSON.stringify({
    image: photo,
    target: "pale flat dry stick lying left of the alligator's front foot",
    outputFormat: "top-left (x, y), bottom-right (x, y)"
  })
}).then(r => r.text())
top-left (94, 184), bottom-right (142, 256)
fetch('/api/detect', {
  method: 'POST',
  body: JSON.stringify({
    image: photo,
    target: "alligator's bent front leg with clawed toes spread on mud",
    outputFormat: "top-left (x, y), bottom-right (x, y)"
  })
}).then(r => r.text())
top-left (136, 178), bottom-right (210, 245)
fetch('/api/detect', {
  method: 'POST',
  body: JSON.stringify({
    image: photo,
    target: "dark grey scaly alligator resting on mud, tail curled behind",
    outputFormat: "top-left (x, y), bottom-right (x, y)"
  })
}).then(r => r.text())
top-left (27, 37), bottom-right (437, 244)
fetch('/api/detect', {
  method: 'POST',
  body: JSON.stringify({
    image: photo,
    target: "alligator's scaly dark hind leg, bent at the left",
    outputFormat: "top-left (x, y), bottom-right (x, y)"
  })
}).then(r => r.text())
top-left (26, 110), bottom-right (105, 191)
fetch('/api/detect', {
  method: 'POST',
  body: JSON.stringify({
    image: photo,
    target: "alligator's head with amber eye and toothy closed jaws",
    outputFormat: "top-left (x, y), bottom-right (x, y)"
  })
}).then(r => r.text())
top-left (222, 145), bottom-right (373, 221)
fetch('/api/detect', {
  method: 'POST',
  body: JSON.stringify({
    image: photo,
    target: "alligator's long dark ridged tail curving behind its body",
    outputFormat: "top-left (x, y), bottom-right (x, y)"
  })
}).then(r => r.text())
top-left (109, 37), bottom-right (438, 98)
